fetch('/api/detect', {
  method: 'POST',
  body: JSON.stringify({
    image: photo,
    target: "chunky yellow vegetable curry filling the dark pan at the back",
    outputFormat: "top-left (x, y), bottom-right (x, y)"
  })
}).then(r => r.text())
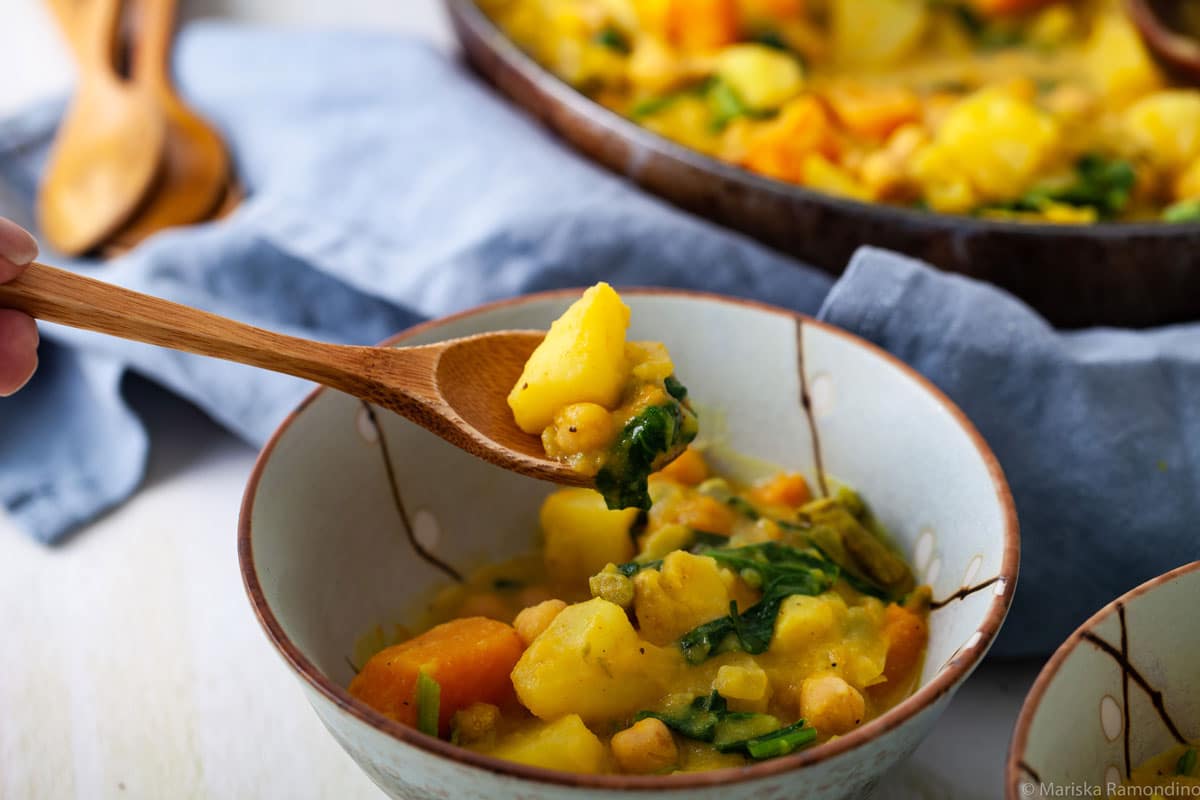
top-left (480, 0), bottom-right (1200, 223)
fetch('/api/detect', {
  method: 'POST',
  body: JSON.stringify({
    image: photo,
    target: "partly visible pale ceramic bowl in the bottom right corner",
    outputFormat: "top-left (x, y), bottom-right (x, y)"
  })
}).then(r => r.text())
top-left (1006, 561), bottom-right (1200, 800)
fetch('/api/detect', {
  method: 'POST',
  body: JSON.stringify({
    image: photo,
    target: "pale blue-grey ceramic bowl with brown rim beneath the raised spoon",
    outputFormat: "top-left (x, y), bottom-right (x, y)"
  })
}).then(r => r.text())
top-left (239, 290), bottom-right (1019, 800)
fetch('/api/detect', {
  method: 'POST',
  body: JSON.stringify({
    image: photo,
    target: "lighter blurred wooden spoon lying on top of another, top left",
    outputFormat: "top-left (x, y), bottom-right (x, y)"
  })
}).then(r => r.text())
top-left (37, 0), bottom-right (167, 255)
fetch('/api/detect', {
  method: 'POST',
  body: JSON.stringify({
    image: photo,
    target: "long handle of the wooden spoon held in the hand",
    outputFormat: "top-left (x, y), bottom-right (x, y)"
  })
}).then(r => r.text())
top-left (0, 264), bottom-right (376, 397)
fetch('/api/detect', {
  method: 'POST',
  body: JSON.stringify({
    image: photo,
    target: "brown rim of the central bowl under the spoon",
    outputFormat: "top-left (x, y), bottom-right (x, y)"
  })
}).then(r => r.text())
top-left (238, 287), bottom-right (1020, 790)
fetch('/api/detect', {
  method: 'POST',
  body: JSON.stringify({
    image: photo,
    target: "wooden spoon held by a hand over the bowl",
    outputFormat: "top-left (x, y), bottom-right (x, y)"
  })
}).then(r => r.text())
top-left (0, 264), bottom-right (592, 486)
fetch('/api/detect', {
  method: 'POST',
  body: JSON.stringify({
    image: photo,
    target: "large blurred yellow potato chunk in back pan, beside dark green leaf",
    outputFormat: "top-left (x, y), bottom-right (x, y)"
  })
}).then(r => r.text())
top-left (913, 89), bottom-right (1060, 205)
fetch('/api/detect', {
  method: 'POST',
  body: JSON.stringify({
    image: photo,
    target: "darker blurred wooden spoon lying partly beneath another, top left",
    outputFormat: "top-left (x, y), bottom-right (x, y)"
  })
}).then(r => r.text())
top-left (115, 0), bottom-right (230, 247)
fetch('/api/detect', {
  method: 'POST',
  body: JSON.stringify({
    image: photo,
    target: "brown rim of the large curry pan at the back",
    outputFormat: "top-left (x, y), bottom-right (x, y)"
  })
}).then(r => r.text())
top-left (442, 0), bottom-right (1200, 241)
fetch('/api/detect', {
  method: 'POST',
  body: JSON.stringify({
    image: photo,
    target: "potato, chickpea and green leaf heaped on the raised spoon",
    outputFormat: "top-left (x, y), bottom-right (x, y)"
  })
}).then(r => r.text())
top-left (509, 283), bottom-right (698, 510)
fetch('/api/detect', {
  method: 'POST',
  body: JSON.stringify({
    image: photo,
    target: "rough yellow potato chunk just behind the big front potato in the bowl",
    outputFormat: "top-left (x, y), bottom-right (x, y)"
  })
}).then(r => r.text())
top-left (634, 551), bottom-right (730, 645)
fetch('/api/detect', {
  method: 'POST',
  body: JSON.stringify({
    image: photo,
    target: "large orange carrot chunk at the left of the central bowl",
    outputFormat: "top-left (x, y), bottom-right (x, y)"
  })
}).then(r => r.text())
top-left (350, 616), bottom-right (524, 736)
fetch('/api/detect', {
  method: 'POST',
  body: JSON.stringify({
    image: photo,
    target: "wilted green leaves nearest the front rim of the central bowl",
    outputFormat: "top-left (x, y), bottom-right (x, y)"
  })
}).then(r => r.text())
top-left (634, 691), bottom-right (817, 759)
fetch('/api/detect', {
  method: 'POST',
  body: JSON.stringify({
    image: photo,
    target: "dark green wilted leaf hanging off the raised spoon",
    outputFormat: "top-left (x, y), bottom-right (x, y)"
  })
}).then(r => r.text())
top-left (596, 401), bottom-right (698, 509)
